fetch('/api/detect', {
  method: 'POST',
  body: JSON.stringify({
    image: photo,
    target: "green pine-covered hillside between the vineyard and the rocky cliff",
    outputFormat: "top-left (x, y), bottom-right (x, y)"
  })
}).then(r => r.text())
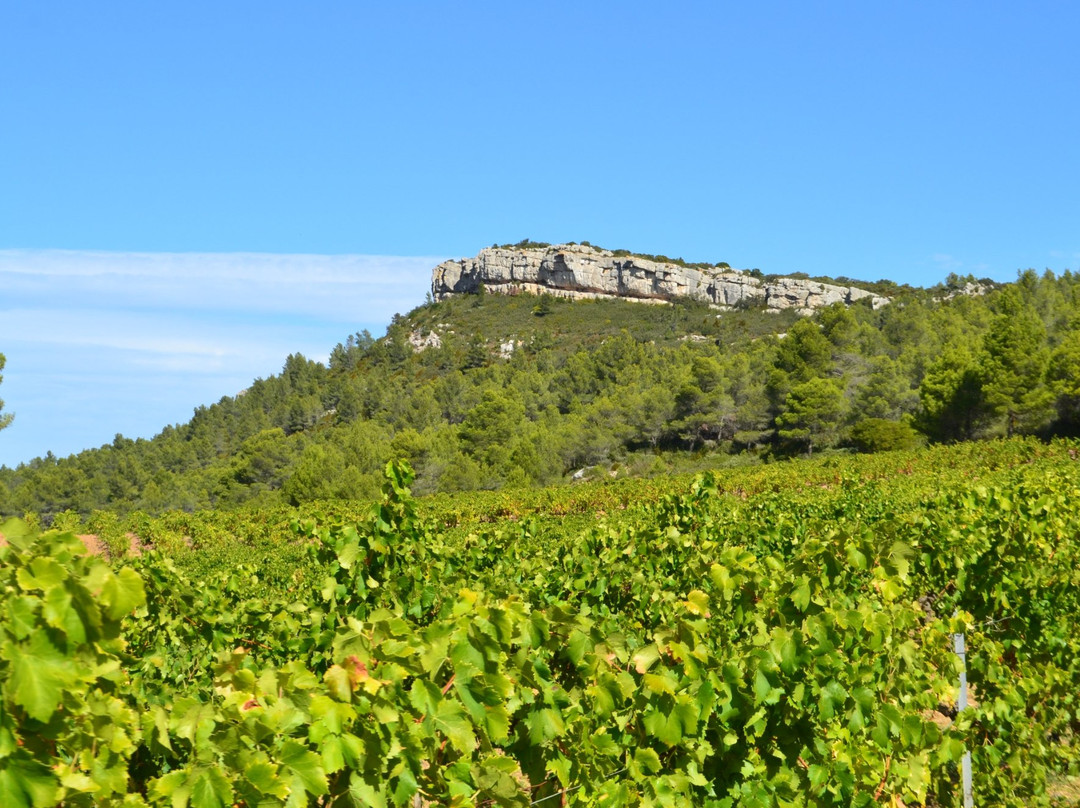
top-left (0, 270), bottom-right (1080, 521)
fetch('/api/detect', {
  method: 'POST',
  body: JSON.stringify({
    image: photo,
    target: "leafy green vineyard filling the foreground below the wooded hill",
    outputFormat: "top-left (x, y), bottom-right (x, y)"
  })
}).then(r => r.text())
top-left (0, 440), bottom-right (1080, 808)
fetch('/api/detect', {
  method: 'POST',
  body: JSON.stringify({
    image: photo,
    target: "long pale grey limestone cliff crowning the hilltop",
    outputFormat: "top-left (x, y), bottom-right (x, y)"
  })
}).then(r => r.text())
top-left (431, 244), bottom-right (889, 313)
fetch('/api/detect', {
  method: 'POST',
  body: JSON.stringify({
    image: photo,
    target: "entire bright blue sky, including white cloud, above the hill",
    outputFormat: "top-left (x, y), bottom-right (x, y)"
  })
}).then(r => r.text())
top-left (0, 0), bottom-right (1080, 464)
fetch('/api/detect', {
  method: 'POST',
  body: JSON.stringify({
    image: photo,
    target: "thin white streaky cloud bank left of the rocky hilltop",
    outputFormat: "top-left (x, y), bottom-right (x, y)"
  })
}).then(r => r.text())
top-left (0, 250), bottom-right (441, 466)
